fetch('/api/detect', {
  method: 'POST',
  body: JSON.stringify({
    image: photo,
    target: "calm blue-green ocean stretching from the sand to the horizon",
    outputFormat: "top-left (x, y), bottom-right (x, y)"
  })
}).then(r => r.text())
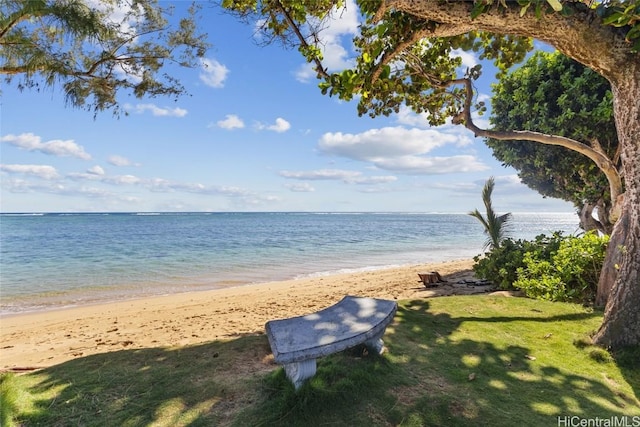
top-left (0, 212), bottom-right (579, 315)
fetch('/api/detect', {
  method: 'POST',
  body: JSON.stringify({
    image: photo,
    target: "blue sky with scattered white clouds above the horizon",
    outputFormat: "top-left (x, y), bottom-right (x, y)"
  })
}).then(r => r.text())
top-left (0, 0), bottom-right (574, 213)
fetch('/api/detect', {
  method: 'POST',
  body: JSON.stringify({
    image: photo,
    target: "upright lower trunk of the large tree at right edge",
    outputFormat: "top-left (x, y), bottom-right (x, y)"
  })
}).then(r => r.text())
top-left (594, 66), bottom-right (640, 349)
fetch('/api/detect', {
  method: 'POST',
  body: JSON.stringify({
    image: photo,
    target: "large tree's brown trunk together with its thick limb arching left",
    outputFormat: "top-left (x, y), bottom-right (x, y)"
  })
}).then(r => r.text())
top-left (376, 0), bottom-right (640, 349)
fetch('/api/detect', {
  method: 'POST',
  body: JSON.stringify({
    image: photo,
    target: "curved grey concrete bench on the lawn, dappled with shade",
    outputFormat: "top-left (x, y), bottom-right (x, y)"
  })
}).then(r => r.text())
top-left (265, 296), bottom-right (398, 389)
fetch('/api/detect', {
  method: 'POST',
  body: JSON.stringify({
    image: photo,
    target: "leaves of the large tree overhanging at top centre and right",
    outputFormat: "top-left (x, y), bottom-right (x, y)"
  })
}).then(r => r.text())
top-left (222, 0), bottom-right (640, 125)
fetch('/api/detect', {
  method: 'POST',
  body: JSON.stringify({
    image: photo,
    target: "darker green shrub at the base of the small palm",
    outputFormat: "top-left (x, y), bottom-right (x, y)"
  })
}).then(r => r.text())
top-left (473, 232), bottom-right (564, 289)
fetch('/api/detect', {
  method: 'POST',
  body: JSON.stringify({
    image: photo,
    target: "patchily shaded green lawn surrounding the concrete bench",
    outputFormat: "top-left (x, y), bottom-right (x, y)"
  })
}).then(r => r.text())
top-left (5, 296), bottom-right (640, 426)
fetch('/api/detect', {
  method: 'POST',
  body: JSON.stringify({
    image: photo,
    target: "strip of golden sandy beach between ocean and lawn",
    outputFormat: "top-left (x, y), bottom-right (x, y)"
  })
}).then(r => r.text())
top-left (0, 260), bottom-right (487, 371)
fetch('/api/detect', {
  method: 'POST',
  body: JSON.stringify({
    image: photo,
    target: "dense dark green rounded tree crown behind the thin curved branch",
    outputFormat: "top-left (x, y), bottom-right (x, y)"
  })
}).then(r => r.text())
top-left (486, 52), bottom-right (618, 232)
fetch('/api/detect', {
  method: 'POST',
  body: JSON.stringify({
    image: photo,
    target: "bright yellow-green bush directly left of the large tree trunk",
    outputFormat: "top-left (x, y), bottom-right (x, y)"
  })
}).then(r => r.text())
top-left (513, 232), bottom-right (609, 304)
